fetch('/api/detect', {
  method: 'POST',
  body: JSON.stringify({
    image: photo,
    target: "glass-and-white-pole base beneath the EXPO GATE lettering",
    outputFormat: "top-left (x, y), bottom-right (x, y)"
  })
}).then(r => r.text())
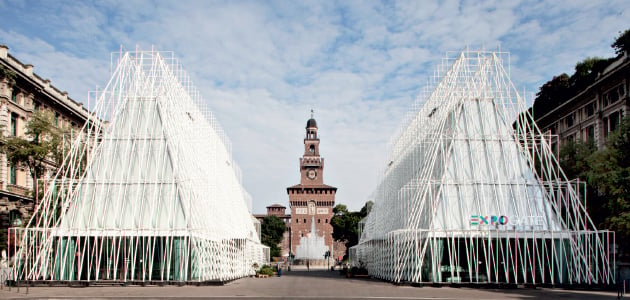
top-left (350, 231), bottom-right (614, 285)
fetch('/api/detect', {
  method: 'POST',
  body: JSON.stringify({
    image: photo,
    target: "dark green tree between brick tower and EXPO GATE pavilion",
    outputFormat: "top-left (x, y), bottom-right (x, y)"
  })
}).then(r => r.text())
top-left (330, 201), bottom-right (374, 257)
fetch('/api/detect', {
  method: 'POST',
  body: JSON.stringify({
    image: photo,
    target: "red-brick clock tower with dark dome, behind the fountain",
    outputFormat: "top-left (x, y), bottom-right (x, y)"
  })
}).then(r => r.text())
top-left (287, 110), bottom-right (337, 260)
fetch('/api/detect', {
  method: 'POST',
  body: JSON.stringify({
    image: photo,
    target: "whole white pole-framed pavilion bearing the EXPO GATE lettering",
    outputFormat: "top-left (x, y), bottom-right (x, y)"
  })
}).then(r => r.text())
top-left (350, 50), bottom-right (615, 284)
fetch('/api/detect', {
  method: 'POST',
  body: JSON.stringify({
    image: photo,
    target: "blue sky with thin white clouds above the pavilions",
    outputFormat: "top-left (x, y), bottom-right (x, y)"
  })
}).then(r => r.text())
top-left (0, 0), bottom-right (630, 213)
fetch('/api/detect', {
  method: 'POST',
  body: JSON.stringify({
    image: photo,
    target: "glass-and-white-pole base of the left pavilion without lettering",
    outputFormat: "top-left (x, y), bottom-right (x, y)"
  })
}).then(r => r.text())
top-left (13, 230), bottom-right (258, 282)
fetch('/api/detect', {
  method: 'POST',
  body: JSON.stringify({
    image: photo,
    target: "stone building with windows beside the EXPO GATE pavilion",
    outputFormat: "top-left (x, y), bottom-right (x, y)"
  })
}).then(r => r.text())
top-left (534, 53), bottom-right (630, 150)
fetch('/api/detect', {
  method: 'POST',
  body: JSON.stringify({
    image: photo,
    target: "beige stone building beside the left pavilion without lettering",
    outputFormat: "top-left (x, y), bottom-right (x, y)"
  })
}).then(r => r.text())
top-left (0, 45), bottom-right (94, 249)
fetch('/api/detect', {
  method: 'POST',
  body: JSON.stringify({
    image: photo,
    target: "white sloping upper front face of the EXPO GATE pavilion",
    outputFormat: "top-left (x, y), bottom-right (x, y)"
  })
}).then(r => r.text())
top-left (430, 95), bottom-right (562, 230)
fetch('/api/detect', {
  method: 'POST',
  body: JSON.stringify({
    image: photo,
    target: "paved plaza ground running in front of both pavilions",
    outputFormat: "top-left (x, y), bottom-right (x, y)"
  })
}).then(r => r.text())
top-left (0, 268), bottom-right (617, 300)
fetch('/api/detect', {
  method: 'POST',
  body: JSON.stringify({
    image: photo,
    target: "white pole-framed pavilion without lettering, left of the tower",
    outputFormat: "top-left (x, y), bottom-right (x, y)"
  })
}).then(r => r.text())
top-left (12, 50), bottom-right (265, 282)
